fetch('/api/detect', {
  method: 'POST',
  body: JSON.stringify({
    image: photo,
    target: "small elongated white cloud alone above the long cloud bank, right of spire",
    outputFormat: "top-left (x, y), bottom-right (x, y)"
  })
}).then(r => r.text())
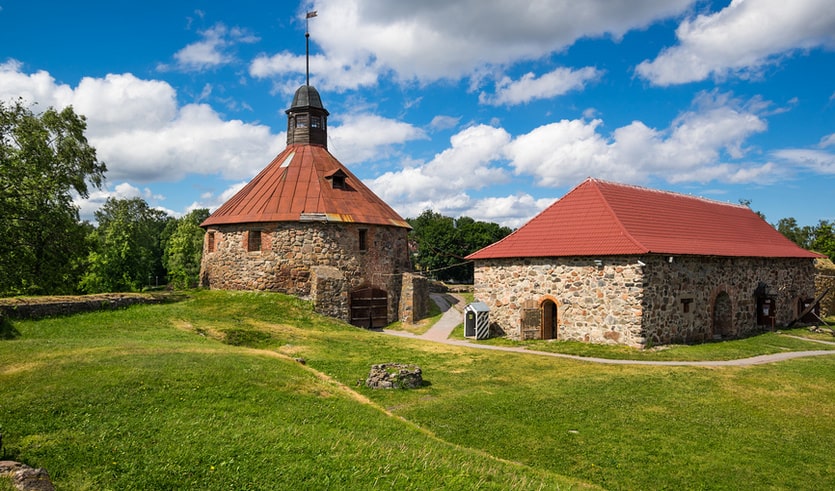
top-left (479, 67), bottom-right (602, 106)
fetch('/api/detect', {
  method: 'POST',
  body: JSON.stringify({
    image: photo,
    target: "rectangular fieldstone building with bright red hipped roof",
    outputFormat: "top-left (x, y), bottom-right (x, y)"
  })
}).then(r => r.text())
top-left (468, 178), bottom-right (821, 347)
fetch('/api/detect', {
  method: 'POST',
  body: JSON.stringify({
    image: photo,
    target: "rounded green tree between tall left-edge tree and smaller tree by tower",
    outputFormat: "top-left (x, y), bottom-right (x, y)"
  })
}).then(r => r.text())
top-left (81, 198), bottom-right (172, 293)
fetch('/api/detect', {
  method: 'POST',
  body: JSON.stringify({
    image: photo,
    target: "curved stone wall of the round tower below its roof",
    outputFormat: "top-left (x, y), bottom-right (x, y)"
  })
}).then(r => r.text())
top-left (200, 222), bottom-right (411, 321)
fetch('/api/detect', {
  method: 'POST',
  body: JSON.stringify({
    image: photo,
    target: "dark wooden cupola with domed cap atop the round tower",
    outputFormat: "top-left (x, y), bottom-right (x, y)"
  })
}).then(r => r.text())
top-left (285, 85), bottom-right (329, 148)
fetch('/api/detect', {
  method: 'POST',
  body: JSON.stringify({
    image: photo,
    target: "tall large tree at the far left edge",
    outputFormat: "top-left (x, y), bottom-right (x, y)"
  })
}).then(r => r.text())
top-left (0, 99), bottom-right (106, 294)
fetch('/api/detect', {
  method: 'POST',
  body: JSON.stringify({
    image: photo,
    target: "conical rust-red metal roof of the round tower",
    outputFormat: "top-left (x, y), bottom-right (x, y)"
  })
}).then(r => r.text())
top-left (201, 144), bottom-right (411, 228)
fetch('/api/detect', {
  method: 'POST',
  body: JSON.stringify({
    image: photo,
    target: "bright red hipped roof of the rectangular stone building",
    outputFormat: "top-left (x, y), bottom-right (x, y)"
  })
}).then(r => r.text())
top-left (467, 178), bottom-right (819, 259)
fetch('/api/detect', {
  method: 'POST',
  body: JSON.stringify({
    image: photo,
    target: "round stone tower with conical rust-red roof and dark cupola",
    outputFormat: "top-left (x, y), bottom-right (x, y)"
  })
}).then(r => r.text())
top-left (200, 85), bottom-right (411, 327)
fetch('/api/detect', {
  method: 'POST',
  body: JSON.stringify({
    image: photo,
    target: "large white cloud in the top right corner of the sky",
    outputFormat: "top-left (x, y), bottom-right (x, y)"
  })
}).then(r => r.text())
top-left (636, 0), bottom-right (835, 85)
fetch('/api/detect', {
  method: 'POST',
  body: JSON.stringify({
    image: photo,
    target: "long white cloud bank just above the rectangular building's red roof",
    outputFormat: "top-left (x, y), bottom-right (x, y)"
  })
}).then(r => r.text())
top-left (369, 92), bottom-right (776, 226)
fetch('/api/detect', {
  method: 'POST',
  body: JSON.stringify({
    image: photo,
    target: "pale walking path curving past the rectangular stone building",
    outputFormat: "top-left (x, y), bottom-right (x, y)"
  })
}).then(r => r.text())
top-left (383, 293), bottom-right (835, 367)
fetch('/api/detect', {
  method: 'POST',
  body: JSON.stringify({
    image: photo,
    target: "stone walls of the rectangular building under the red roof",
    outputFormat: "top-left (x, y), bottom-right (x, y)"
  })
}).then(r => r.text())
top-left (474, 256), bottom-right (814, 347)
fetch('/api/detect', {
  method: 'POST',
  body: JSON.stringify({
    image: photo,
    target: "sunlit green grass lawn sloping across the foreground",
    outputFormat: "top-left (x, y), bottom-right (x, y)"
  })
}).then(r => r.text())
top-left (0, 291), bottom-right (835, 490)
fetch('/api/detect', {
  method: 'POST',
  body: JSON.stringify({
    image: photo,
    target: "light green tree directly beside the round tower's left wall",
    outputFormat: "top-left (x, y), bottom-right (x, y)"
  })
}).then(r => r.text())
top-left (163, 208), bottom-right (209, 288)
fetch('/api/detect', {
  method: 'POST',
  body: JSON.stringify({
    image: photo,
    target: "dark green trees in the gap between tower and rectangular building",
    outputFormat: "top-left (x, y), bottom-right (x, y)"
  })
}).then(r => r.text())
top-left (407, 210), bottom-right (512, 283)
